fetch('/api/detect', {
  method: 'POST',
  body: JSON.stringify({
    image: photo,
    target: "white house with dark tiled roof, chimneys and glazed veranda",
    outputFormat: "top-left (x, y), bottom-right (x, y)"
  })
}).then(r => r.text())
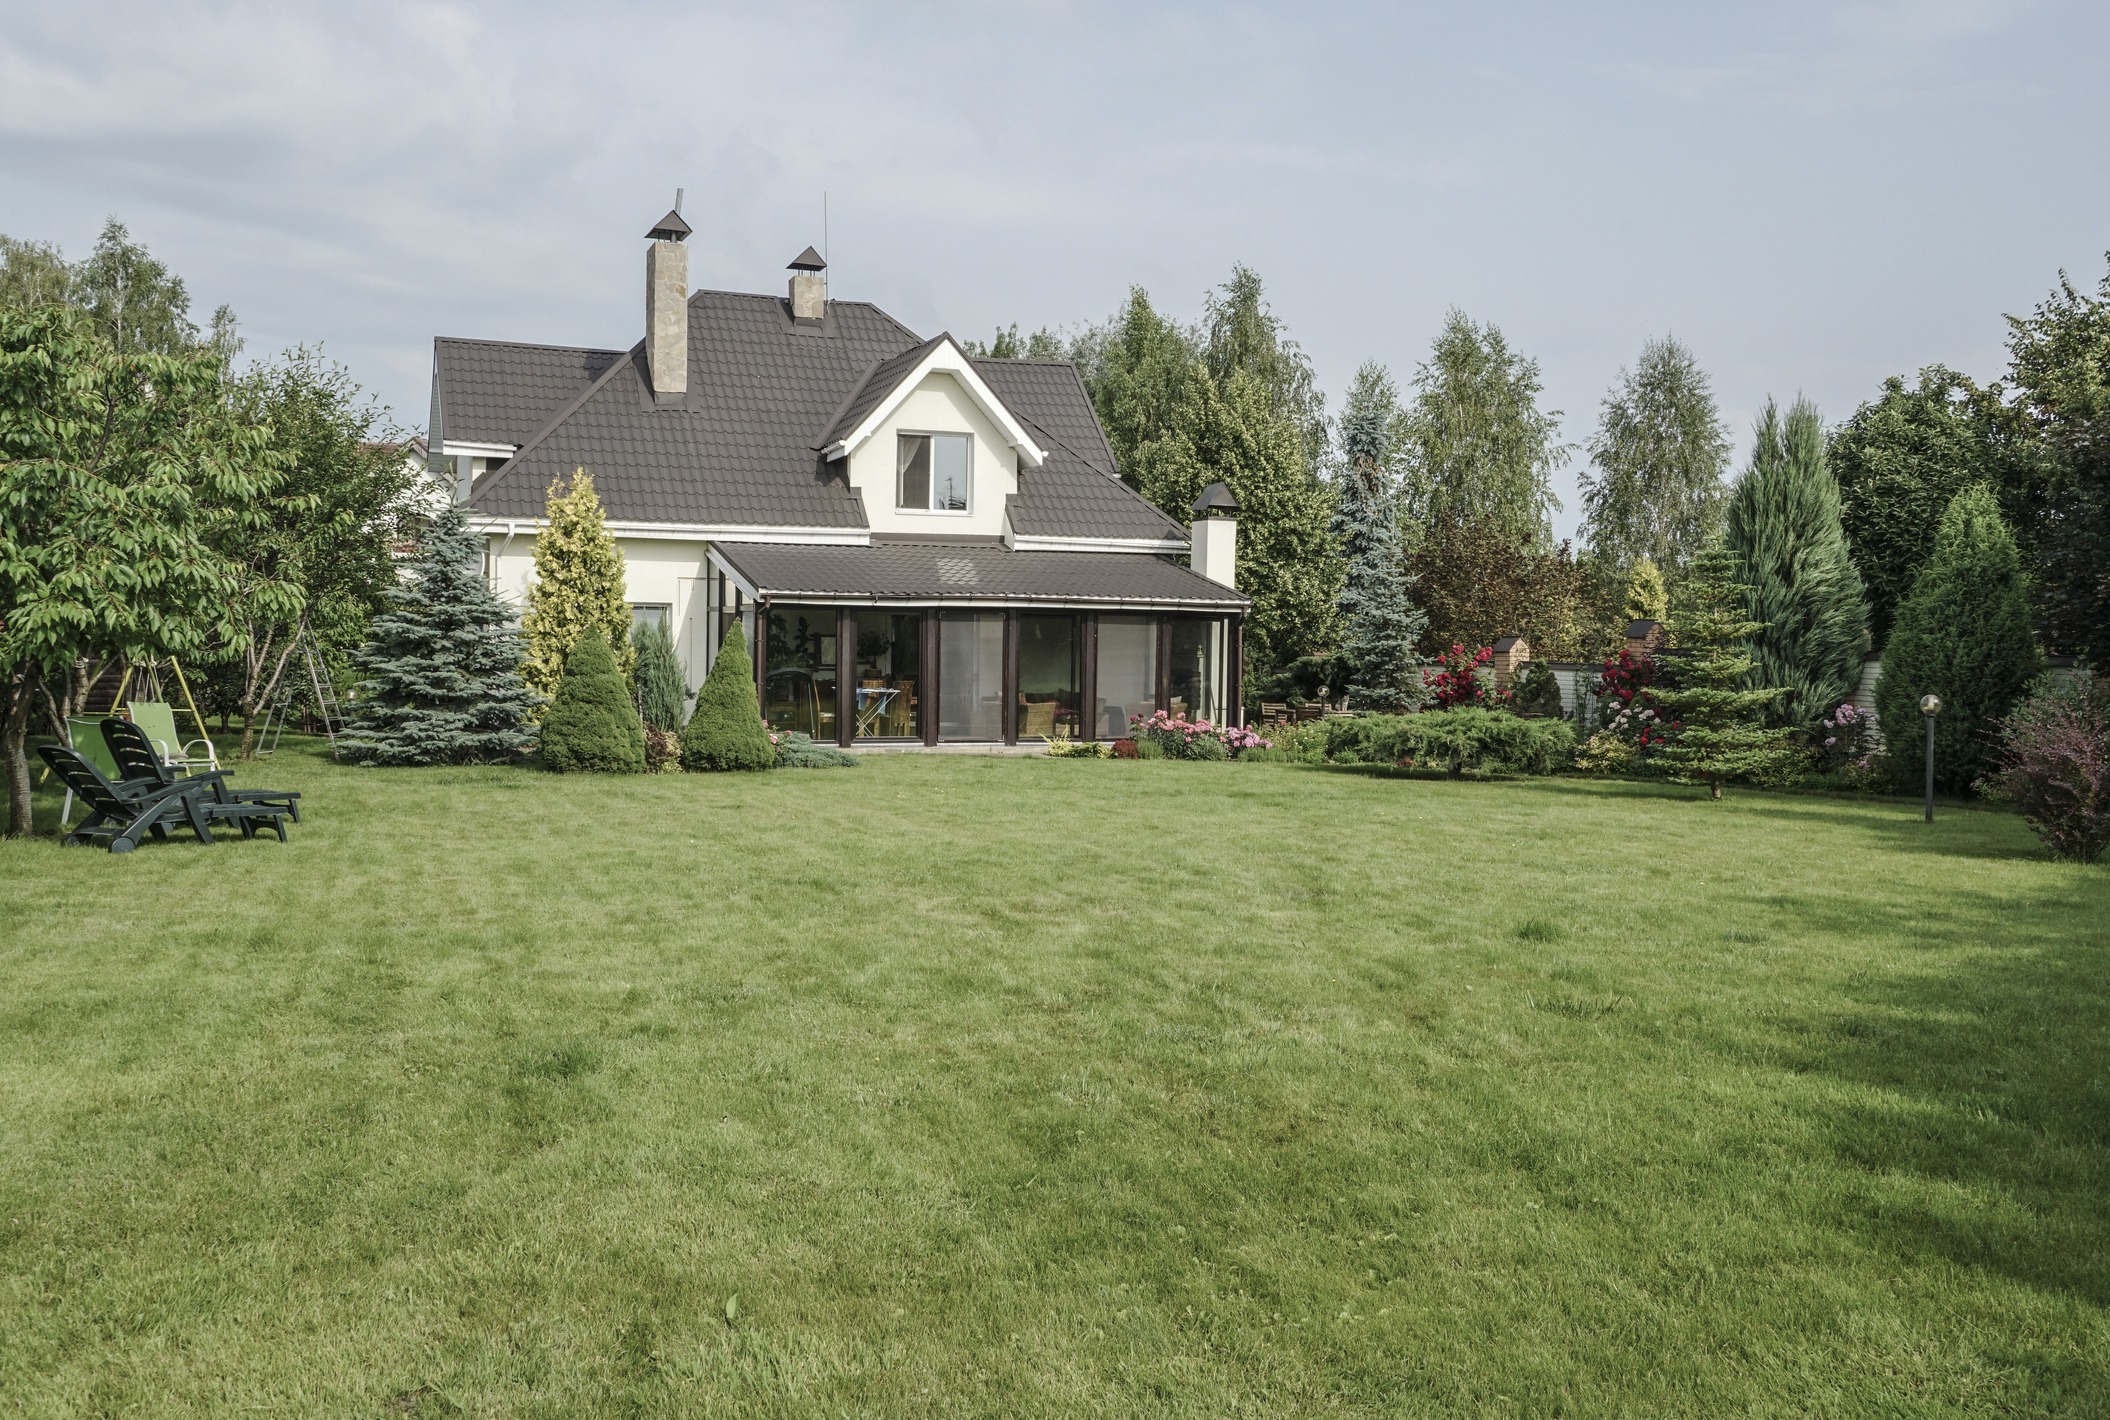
top-left (426, 213), bottom-right (1249, 747)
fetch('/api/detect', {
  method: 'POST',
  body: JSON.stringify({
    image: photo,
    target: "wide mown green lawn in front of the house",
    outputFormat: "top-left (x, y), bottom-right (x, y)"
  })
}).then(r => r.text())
top-left (0, 753), bottom-right (2110, 1420)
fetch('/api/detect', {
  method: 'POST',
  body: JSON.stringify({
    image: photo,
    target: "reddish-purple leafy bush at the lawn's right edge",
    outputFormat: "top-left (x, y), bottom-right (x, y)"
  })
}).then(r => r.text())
top-left (1992, 690), bottom-right (2110, 863)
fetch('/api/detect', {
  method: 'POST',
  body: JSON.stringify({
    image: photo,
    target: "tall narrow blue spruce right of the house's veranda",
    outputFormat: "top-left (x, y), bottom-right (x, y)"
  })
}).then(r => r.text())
top-left (1334, 363), bottom-right (1428, 711)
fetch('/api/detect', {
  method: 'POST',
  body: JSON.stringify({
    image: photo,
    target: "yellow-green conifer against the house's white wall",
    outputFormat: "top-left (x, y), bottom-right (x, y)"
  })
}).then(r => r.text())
top-left (521, 468), bottom-right (633, 696)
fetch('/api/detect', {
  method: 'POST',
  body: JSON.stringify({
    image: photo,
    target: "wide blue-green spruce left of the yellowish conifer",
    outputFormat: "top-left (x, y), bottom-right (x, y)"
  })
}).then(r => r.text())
top-left (338, 508), bottom-right (540, 764)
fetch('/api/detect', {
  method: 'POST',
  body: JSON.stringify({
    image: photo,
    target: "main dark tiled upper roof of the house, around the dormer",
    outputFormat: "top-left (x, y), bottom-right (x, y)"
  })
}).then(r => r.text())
top-left (435, 291), bottom-right (1186, 542)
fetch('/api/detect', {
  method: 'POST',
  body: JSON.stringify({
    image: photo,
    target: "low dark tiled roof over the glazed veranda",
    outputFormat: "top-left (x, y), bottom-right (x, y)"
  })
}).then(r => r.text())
top-left (717, 542), bottom-right (1249, 610)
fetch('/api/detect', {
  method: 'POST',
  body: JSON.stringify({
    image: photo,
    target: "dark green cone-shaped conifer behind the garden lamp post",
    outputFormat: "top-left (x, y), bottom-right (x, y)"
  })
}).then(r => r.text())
top-left (1876, 483), bottom-right (2042, 793)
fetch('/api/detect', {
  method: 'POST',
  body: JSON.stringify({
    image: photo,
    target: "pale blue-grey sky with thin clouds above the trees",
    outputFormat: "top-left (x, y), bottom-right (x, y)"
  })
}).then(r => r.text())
top-left (0, 0), bottom-right (2110, 534)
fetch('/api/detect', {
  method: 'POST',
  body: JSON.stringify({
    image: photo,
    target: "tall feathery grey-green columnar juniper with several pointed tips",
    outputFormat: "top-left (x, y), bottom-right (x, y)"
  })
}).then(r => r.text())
top-left (1726, 399), bottom-right (1867, 726)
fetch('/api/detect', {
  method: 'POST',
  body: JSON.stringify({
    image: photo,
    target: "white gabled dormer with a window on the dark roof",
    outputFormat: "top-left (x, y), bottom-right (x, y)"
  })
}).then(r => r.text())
top-left (819, 335), bottom-right (1047, 538)
